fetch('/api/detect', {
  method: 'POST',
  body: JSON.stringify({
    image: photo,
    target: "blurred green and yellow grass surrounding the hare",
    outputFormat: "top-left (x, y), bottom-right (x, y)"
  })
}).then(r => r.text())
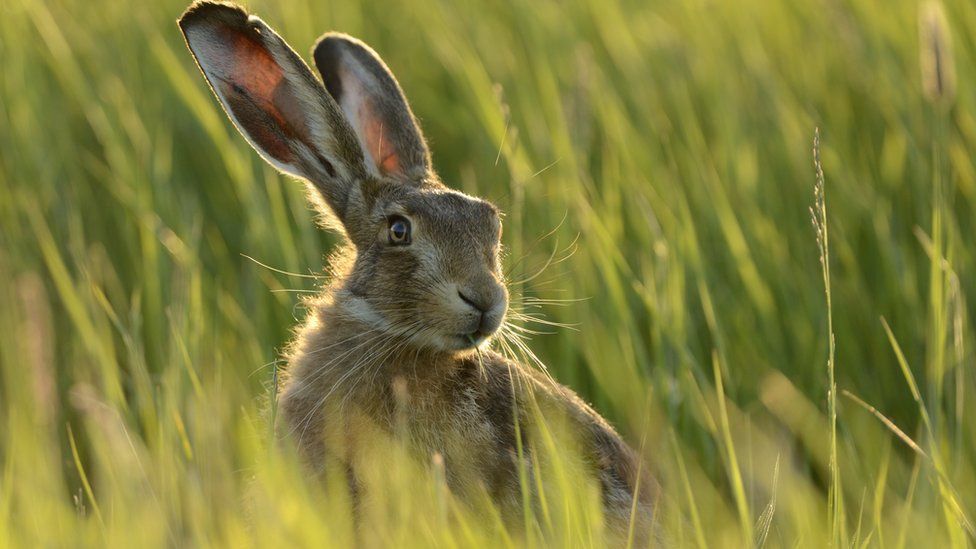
top-left (0, 0), bottom-right (976, 547)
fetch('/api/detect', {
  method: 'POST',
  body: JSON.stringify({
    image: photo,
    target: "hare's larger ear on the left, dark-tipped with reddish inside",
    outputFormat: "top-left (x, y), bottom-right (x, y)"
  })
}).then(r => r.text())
top-left (179, 2), bottom-right (366, 220)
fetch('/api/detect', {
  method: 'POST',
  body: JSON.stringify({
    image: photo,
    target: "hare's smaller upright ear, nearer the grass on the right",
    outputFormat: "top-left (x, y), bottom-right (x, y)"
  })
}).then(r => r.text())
top-left (313, 33), bottom-right (430, 182)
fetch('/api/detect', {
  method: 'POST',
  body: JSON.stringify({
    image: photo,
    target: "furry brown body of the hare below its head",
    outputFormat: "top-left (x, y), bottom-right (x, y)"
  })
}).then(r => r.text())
top-left (279, 280), bottom-right (654, 533)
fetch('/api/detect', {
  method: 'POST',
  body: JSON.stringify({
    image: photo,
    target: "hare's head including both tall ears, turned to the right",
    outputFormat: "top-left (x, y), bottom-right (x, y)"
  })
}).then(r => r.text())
top-left (180, 2), bottom-right (508, 351)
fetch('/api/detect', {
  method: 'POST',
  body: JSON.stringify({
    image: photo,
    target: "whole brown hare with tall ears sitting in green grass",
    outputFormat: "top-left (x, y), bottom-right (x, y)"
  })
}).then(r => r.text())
top-left (179, 2), bottom-right (656, 536)
